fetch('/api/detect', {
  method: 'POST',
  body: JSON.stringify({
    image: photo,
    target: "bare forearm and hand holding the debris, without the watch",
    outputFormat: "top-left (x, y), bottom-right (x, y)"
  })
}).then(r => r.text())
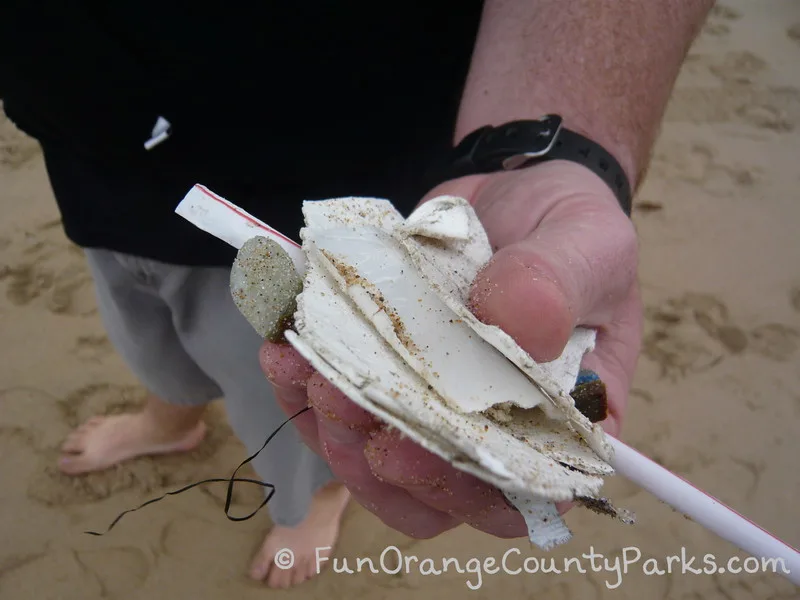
top-left (261, 0), bottom-right (713, 538)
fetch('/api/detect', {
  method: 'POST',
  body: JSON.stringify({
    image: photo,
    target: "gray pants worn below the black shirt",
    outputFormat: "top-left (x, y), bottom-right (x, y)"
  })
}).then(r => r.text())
top-left (85, 249), bottom-right (333, 526)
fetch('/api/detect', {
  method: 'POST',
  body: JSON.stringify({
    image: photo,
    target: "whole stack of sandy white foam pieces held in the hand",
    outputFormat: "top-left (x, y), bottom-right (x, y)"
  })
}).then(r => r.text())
top-left (286, 196), bottom-right (636, 548)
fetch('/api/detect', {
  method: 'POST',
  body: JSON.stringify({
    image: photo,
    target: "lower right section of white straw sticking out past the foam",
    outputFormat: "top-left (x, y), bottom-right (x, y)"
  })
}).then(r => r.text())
top-left (609, 436), bottom-right (800, 585)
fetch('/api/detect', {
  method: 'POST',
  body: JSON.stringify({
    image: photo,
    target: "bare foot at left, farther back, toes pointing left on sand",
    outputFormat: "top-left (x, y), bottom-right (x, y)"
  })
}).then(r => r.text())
top-left (58, 410), bottom-right (206, 475)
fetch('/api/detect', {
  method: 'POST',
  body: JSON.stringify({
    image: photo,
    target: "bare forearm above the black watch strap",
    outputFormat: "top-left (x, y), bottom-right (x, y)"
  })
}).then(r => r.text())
top-left (456, 0), bottom-right (714, 188)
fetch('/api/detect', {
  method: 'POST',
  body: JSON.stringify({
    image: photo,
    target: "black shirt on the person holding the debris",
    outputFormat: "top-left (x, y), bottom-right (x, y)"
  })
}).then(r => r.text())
top-left (0, 0), bottom-right (482, 265)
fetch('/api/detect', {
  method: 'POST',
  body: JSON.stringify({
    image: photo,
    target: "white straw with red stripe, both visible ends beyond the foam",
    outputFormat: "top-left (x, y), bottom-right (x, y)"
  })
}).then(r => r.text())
top-left (175, 185), bottom-right (800, 585)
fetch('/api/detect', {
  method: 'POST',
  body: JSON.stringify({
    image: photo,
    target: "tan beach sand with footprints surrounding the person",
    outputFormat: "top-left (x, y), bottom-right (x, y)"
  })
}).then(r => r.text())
top-left (0, 0), bottom-right (800, 600)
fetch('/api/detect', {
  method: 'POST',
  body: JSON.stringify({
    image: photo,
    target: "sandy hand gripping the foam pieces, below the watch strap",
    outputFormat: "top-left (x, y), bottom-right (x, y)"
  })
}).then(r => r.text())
top-left (261, 161), bottom-right (642, 538)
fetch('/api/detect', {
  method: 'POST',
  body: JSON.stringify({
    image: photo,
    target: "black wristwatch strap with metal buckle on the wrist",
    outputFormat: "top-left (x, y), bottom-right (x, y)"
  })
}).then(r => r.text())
top-left (447, 115), bottom-right (632, 217)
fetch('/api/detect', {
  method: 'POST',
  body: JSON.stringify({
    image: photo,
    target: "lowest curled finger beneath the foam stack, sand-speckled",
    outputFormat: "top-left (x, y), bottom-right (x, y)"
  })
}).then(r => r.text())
top-left (366, 430), bottom-right (527, 538)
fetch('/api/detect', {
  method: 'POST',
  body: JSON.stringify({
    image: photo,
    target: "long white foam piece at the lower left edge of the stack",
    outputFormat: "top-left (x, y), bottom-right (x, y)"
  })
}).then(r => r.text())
top-left (294, 209), bottom-right (602, 500)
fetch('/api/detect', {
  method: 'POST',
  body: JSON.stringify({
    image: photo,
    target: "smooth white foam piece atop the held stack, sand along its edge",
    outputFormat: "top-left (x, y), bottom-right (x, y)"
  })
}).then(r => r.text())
top-left (305, 227), bottom-right (546, 413)
